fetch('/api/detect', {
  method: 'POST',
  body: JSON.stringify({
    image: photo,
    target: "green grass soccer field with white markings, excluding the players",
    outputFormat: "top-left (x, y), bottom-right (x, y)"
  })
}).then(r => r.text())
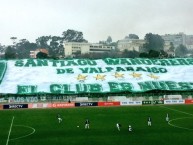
top-left (0, 105), bottom-right (193, 145)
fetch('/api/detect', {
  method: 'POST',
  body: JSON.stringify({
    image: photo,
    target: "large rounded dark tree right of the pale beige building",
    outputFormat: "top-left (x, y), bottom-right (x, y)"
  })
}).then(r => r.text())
top-left (143, 33), bottom-right (164, 52)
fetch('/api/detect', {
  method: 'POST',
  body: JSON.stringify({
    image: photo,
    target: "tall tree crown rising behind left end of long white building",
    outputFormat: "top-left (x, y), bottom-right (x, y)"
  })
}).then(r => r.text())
top-left (62, 29), bottom-right (88, 42)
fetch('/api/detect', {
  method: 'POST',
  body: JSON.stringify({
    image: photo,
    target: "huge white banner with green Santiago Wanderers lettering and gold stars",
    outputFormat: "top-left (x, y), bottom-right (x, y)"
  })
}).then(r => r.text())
top-left (0, 58), bottom-right (193, 94)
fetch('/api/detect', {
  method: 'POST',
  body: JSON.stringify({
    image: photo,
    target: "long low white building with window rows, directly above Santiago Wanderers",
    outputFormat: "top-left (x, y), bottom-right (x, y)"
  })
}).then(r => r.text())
top-left (64, 42), bottom-right (114, 56)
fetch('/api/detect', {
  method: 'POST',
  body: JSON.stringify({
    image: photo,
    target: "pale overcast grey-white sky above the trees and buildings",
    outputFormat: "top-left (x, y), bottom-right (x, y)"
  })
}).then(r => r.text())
top-left (0, 0), bottom-right (193, 45)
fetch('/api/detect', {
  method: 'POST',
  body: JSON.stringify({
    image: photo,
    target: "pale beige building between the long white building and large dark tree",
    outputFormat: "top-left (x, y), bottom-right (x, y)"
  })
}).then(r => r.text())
top-left (117, 39), bottom-right (145, 52)
